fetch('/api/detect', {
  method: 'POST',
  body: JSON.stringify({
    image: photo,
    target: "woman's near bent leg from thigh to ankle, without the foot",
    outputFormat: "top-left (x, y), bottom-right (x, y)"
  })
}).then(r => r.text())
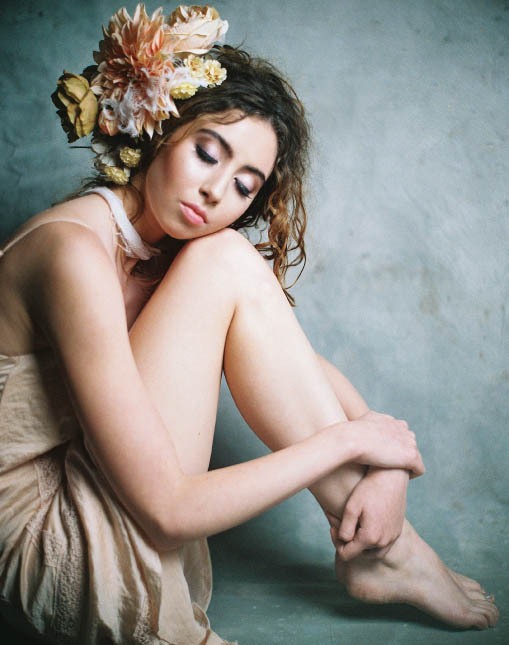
top-left (131, 230), bottom-right (364, 515)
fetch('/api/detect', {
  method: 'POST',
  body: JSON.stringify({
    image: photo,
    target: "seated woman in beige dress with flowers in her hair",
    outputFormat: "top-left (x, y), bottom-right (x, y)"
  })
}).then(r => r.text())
top-left (0, 6), bottom-right (497, 645)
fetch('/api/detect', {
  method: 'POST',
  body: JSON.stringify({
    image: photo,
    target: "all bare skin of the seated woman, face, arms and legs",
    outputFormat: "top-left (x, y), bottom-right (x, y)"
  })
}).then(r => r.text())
top-left (0, 117), bottom-right (498, 628)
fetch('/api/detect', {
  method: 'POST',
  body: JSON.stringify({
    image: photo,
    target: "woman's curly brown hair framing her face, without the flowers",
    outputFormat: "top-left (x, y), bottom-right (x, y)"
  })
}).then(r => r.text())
top-left (83, 45), bottom-right (310, 304)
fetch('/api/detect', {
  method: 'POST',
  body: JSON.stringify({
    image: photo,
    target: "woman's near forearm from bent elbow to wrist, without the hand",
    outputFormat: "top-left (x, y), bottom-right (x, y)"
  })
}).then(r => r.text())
top-left (151, 424), bottom-right (358, 548)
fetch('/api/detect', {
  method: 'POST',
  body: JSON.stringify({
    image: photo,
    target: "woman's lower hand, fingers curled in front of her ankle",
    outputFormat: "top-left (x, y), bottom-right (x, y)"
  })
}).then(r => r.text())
top-left (329, 468), bottom-right (408, 561)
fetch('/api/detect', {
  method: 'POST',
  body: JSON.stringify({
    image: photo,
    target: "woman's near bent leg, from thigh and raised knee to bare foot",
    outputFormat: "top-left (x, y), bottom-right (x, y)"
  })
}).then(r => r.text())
top-left (132, 231), bottom-right (497, 627)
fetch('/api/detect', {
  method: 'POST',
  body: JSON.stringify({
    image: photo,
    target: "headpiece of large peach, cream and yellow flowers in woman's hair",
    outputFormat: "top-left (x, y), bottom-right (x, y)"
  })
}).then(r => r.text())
top-left (52, 4), bottom-right (228, 184)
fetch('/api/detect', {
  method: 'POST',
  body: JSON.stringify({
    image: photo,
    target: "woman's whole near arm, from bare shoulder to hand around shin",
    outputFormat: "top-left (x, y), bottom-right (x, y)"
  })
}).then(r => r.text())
top-left (30, 225), bottom-right (422, 548)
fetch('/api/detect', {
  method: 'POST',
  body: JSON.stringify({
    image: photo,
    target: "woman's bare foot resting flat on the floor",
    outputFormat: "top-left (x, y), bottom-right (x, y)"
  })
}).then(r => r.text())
top-left (336, 522), bottom-right (498, 629)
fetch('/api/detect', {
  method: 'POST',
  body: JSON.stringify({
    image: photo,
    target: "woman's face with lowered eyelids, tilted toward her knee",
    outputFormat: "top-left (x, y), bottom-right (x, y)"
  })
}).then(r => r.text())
top-left (136, 117), bottom-right (277, 243)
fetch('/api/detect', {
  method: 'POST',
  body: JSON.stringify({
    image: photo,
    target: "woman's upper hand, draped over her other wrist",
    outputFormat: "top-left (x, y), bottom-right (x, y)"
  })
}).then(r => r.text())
top-left (344, 411), bottom-right (425, 476)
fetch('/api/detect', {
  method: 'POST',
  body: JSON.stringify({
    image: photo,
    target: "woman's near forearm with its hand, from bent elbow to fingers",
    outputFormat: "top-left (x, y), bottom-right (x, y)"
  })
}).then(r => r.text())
top-left (156, 412), bottom-right (424, 548)
